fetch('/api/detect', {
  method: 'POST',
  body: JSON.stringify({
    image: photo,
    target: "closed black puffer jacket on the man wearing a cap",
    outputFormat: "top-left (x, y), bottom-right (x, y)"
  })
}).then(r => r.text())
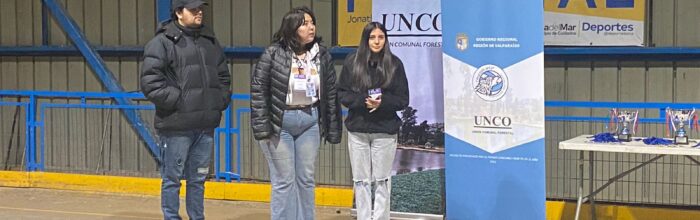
top-left (141, 22), bottom-right (231, 131)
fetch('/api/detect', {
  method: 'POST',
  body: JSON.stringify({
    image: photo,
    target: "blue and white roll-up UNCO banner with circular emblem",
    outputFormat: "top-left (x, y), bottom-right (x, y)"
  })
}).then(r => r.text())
top-left (442, 0), bottom-right (545, 219)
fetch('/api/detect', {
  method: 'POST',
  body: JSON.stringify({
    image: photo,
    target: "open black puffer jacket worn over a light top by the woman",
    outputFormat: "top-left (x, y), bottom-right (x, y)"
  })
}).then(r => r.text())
top-left (250, 43), bottom-right (342, 144)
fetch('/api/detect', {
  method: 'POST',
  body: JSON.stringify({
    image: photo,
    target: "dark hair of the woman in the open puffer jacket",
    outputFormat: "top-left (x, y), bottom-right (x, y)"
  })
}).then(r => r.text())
top-left (272, 6), bottom-right (321, 53)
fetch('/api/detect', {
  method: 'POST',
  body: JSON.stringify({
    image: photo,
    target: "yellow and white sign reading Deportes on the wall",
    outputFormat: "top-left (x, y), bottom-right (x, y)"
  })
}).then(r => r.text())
top-left (544, 0), bottom-right (646, 46)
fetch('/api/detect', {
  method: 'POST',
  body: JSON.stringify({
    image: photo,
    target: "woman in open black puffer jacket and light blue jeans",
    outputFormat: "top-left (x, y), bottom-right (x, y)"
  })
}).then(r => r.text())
top-left (250, 7), bottom-right (342, 220)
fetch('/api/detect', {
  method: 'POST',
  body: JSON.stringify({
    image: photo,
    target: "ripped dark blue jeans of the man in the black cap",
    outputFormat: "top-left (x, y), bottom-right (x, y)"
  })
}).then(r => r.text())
top-left (160, 130), bottom-right (214, 220)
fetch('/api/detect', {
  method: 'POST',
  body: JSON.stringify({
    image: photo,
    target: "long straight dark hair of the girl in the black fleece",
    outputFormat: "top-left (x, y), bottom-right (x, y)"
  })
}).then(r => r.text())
top-left (350, 22), bottom-right (394, 91)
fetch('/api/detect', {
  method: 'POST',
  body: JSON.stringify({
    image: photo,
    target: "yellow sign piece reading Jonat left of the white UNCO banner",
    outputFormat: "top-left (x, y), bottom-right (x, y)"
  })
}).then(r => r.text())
top-left (336, 0), bottom-right (372, 47)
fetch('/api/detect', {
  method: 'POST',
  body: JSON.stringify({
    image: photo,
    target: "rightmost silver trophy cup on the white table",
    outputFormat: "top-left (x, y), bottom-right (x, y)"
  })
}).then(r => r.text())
top-left (666, 108), bottom-right (698, 144)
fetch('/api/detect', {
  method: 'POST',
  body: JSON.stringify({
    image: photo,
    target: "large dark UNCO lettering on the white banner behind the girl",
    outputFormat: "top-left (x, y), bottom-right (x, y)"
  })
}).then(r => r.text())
top-left (382, 13), bottom-right (442, 33)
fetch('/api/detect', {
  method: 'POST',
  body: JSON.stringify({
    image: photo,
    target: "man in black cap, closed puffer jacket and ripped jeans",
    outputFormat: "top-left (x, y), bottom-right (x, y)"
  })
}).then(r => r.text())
top-left (141, 0), bottom-right (231, 219)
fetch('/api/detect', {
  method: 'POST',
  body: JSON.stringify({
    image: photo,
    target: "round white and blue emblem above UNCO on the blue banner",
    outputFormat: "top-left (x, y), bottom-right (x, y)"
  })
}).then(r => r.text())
top-left (472, 64), bottom-right (508, 101)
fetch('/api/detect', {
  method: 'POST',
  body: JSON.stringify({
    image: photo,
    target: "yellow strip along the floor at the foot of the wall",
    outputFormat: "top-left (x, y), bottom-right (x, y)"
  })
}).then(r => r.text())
top-left (0, 171), bottom-right (700, 220)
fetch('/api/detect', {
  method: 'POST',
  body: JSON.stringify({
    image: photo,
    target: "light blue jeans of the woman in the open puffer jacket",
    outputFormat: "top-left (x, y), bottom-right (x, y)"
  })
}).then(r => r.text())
top-left (259, 108), bottom-right (321, 220)
